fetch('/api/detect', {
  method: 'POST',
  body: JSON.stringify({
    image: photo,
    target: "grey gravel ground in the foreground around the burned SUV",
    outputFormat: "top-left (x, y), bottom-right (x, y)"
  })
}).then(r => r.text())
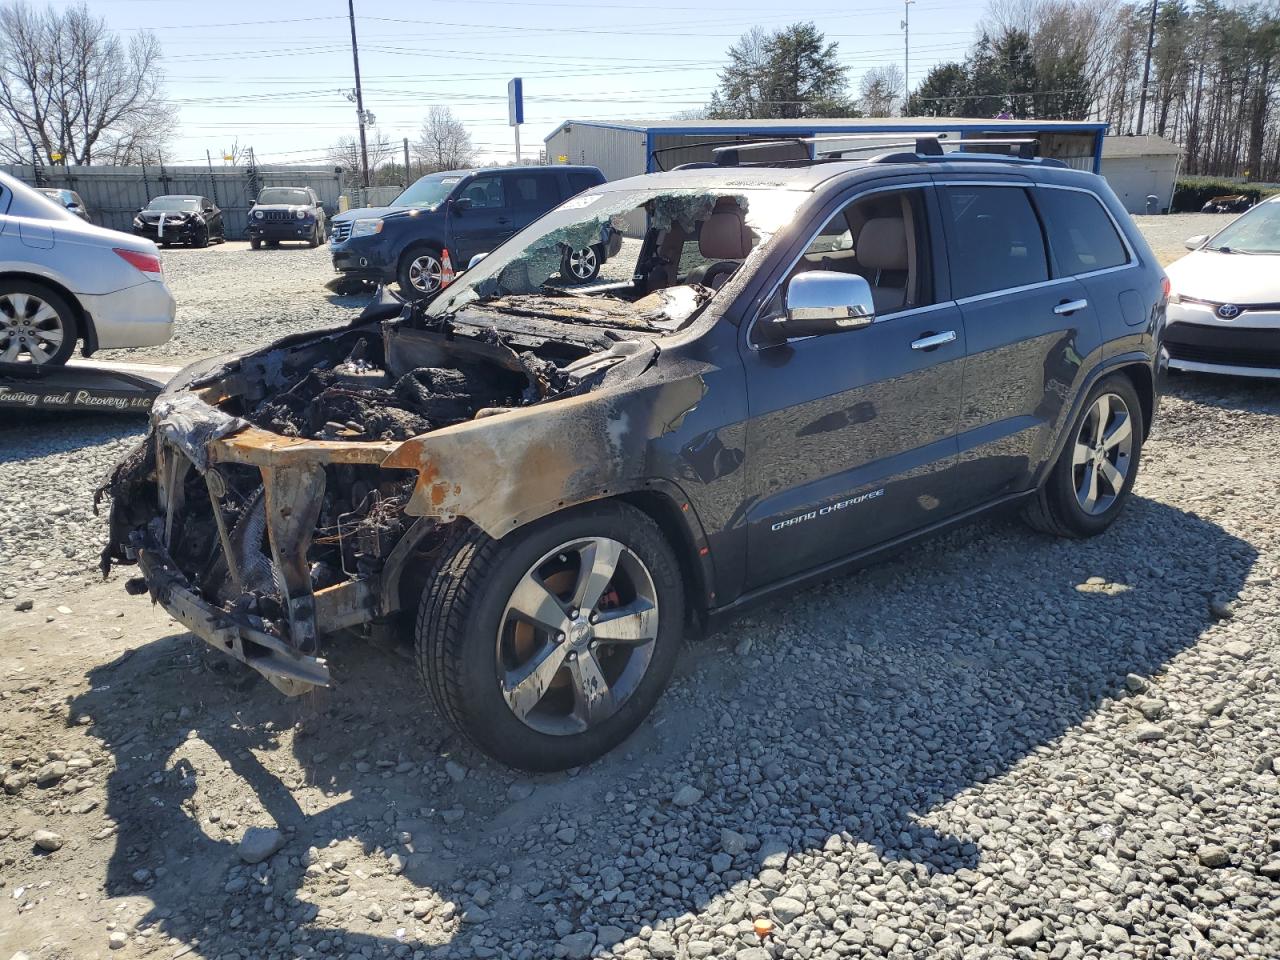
top-left (0, 218), bottom-right (1280, 960)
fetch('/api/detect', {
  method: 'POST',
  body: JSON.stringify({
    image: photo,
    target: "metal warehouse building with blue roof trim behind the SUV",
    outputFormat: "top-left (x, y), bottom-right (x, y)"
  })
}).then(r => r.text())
top-left (545, 116), bottom-right (1107, 180)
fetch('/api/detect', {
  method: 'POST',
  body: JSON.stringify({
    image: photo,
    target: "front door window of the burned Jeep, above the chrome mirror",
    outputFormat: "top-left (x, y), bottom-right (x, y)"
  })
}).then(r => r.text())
top-left (795, 189), bottom-right (934, 314)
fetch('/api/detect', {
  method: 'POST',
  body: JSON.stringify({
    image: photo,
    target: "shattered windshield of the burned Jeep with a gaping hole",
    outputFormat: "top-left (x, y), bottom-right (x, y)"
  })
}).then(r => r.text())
top-left (426, 186), bottom-right (808, 326)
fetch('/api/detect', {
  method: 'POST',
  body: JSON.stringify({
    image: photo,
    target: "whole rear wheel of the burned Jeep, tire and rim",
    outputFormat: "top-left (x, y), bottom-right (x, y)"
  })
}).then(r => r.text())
top-left (1025, 374), bottom-right (1144, 538)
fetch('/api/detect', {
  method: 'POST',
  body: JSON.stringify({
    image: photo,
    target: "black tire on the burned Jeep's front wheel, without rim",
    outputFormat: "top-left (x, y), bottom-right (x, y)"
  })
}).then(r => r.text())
top-left (415, 502), bottom-right (685, 771)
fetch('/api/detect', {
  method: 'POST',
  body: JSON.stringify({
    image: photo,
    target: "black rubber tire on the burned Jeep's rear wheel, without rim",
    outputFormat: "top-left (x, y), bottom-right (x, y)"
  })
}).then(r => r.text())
top-left (1023, 374), bottom-right (1146, 539)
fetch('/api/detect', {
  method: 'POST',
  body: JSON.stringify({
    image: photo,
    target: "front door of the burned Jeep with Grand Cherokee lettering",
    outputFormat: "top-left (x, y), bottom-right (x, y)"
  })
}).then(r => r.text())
top-left (742, 186), bottom-right (965, 590)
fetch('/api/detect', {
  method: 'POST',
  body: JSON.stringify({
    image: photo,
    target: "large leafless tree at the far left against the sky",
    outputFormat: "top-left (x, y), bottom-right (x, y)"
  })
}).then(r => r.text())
top-left (0, 3), bottom-right (174, 164)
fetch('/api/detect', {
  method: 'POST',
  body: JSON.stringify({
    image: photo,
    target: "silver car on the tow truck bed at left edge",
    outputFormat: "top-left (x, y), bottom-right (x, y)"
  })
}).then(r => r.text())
top-left (0, 173), bottom-right (175, 366)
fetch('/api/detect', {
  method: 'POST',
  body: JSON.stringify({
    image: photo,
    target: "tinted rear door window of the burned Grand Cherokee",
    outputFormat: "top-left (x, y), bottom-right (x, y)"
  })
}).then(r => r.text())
top-left (942, 187), bottom-right (1048, 300)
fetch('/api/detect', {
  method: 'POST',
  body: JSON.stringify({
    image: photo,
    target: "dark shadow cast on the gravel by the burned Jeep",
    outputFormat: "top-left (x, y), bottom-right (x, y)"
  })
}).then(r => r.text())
top-left (70, 498), bottom-right (1256, 957)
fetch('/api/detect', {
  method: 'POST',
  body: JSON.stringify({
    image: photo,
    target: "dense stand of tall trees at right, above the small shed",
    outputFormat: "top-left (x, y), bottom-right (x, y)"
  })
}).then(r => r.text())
top-left (908, 0), bottom-right (1280, 180)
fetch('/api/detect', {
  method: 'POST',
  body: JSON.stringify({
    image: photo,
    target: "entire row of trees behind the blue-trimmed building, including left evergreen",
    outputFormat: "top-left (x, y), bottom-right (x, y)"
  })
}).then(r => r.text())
top-left (701, 0), bottom-right (1280, 180)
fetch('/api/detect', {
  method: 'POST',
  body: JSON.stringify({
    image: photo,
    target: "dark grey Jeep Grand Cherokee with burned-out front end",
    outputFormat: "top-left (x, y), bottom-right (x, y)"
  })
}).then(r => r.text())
top-left (104, 144), bottom-right (1167, 769)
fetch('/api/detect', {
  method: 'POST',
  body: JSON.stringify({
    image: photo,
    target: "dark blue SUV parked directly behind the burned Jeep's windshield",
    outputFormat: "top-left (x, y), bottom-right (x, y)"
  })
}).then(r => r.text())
top-left (329, 166), bottom-right (609, 298)
